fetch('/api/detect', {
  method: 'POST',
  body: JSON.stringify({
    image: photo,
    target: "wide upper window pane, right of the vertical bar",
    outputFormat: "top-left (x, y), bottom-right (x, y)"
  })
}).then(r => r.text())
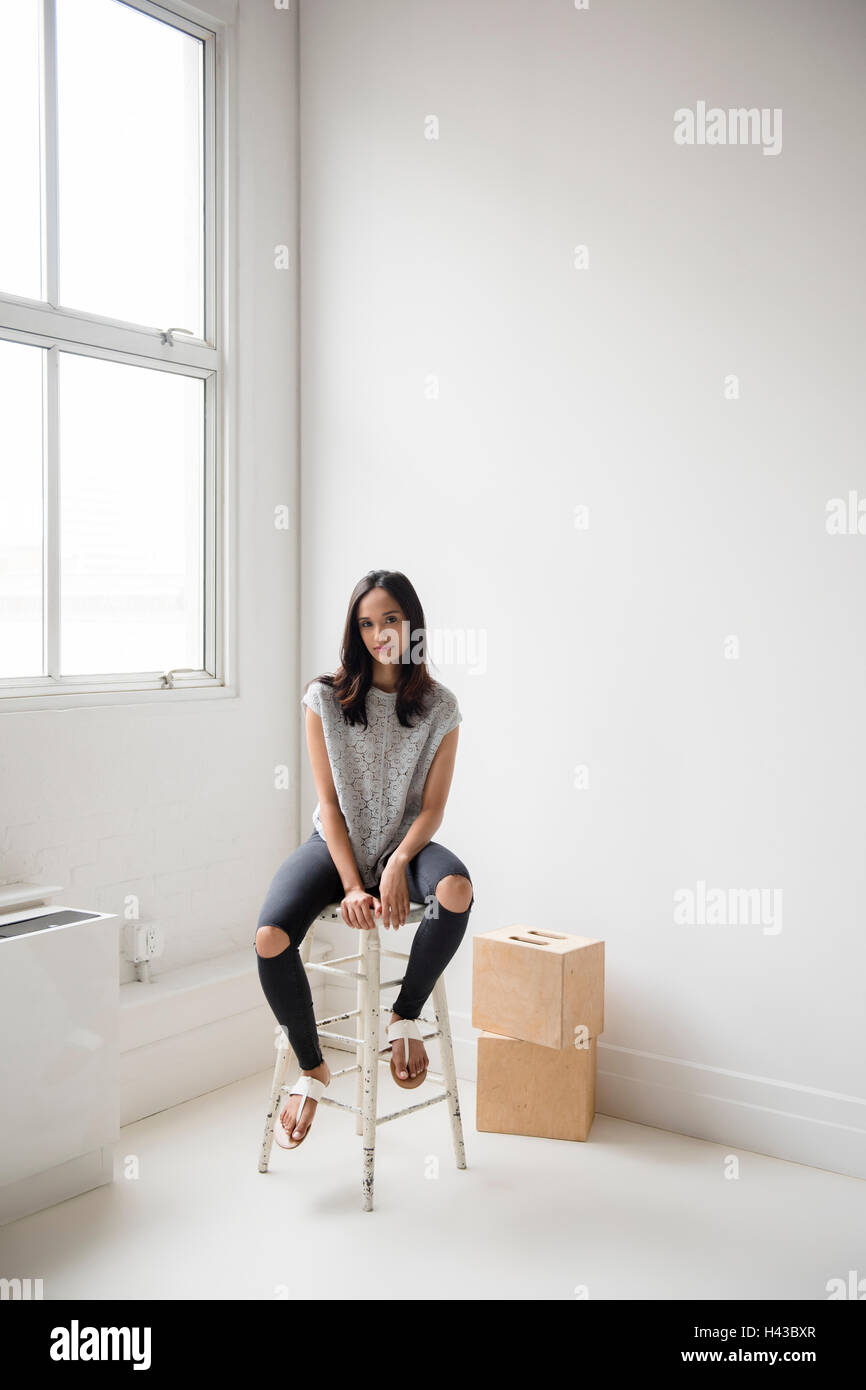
top-left (57, 0), bottom-right (204, 338)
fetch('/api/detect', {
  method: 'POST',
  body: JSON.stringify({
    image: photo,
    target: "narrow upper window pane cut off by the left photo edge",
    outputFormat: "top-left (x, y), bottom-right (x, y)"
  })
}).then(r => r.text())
top-left (0, 0), bottom-right (42, 299)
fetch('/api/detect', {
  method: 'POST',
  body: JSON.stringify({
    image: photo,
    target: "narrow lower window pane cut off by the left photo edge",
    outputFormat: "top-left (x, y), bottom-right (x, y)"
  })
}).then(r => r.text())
top-left (0, 341), bottom-right (43, 676)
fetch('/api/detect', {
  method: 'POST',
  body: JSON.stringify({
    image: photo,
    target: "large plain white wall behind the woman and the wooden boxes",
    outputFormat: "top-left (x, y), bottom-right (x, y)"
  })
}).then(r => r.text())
top-left (301, 0), bottom-right (866, 1176)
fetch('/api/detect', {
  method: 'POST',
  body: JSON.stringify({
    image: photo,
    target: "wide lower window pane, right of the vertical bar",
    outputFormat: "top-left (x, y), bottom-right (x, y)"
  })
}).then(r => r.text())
top-left (58, 352), bottom-right (204, 676)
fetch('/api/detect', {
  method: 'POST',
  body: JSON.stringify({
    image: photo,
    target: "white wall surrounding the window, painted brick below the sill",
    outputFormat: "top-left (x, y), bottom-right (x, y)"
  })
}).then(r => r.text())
top-left (0, 0), bottom-right (297, 978)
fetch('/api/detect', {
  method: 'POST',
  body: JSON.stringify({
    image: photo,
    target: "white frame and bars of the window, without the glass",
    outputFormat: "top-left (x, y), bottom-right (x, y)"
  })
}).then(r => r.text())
top-left (0, 0), bottom-right (238, 712)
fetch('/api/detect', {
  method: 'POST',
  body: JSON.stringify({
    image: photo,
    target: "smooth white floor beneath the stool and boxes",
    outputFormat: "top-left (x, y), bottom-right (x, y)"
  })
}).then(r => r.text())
top-left (0, 1052), bottom-right (866, 1300)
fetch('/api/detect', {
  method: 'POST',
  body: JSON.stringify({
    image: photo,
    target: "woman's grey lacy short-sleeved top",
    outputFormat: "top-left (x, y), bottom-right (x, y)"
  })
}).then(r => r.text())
top-left (302, 681), bottom-right (463, 891)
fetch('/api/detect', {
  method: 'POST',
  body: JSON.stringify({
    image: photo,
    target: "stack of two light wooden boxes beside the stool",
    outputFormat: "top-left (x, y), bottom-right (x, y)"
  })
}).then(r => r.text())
top-left (473, 926), bottom-right (605, 1140)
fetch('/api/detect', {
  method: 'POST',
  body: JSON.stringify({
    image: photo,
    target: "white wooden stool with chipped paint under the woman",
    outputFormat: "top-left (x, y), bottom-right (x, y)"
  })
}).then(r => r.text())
top-left (259, 902), bottom-right (466, 1212)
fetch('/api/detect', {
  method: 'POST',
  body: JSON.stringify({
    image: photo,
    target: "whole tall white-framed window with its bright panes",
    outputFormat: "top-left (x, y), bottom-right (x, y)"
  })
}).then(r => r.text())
top-left (0, 0), bottom-right (225, 709)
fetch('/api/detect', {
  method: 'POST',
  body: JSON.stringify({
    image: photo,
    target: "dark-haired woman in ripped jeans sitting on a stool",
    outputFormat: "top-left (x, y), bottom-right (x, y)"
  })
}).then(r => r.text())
top-left (256, 570), bottom-right (475, 1148)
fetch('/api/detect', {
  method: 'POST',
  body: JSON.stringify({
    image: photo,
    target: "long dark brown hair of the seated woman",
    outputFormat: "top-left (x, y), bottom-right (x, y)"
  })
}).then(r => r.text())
top-left (304, 570), bottom-right (434, 728)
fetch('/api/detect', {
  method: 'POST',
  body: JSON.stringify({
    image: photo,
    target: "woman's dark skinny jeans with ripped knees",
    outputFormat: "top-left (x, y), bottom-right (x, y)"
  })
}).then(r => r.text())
top-left (256, 830), bottom-right (475, 1072)
